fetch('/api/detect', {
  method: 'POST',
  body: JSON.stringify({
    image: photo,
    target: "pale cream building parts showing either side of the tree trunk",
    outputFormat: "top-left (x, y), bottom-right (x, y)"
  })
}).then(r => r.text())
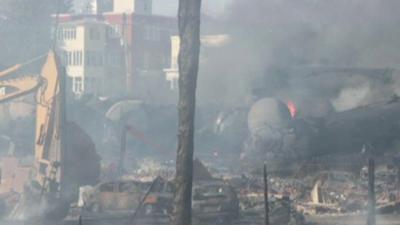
top-left (164, 35), bottom-right (229, 90)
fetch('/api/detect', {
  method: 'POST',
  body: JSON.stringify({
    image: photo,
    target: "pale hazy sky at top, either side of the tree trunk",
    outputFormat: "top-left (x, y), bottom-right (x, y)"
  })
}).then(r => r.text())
top-left (153, 0), bottom-right (233, 16)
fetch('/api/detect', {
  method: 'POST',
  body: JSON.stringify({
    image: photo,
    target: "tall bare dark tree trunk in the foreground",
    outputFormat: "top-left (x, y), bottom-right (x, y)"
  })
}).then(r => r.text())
top-left (172, 0), bottom-right (201, 225)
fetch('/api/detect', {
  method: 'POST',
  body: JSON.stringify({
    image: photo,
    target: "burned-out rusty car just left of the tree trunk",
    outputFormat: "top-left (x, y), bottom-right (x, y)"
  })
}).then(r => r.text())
top-left (82, 178), bottom-right (173, 215)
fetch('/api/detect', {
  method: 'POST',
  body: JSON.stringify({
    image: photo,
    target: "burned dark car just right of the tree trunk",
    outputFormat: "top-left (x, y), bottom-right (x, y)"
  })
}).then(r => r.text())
top-left (192, 180), bottom-right (239, 222)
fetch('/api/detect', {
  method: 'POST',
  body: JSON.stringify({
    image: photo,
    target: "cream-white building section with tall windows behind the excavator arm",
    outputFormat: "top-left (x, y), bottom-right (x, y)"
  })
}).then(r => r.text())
top-left (57, 19), bottom-right (122, 97)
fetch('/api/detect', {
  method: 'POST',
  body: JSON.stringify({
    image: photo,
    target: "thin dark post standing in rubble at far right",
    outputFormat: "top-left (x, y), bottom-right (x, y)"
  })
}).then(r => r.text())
top-left (367, 159), bottom-right (376, 225)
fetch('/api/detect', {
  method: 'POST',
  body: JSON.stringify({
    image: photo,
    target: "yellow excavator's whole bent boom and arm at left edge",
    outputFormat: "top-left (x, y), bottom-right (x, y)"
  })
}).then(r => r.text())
top-left (0, 51), bottom-right (65, 193)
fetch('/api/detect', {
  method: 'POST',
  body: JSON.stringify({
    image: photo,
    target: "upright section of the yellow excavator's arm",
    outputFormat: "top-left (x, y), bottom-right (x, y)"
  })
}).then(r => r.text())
top-left (35, 52), bottom-right (64, 192)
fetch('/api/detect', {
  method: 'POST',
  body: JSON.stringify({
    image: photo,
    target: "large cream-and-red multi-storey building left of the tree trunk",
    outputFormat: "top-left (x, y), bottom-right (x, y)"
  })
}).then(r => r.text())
top-left (57, 0), bottom-right (176, 97)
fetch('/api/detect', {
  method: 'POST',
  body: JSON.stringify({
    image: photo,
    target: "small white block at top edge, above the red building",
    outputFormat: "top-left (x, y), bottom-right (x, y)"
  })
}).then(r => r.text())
top-left (113, 0), bottom-right (153, 15)
